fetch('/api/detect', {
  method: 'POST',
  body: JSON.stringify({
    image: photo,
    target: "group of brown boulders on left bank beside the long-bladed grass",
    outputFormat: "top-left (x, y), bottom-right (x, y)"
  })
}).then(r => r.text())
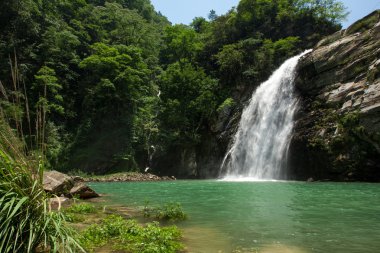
top-left (43, 170), bottom-right (99, 199)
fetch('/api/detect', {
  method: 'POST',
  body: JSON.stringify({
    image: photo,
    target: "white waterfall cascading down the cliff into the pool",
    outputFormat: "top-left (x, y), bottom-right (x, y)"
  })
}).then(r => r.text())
top-left (221, 50), bottom-right (311, 180)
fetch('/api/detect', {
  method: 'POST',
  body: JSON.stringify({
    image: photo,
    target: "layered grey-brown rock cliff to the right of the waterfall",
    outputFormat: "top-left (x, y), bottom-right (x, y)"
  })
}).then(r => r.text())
top-left (290, 10), bottom-right (380, 181)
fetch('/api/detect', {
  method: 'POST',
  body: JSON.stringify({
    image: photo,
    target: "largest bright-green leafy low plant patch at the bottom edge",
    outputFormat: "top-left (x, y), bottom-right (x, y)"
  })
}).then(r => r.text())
top-left (79, 215), bottom-right (183, 253)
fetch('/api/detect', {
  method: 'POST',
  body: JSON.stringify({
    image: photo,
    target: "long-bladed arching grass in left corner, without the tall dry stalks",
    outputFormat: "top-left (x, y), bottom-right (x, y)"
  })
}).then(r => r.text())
top-left (0, 115), bottom-right (83, 253)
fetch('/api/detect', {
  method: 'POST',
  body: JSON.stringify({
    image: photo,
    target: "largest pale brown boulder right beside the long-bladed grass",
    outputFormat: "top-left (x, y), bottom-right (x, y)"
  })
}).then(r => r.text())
top-left (43, 170), bottom-right (74, 195)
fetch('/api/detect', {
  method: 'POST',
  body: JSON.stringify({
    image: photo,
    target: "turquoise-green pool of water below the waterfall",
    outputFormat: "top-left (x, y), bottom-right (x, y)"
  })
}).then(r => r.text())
top-left (91, 181), bottom-right (380, 253)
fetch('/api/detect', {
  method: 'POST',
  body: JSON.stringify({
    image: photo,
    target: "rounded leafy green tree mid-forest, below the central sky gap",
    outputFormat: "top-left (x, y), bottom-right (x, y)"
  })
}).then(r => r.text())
top-left (159, 62), bottom-right (217, 143)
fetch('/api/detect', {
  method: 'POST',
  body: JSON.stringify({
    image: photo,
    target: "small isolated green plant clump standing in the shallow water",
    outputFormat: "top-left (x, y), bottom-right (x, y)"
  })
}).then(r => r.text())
top-left (143, 203), bottom-right (187, 221)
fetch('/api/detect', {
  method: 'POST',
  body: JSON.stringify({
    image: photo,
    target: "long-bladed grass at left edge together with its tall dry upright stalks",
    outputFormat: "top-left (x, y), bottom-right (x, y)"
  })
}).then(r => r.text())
top-left (0, 54), bottom-right (84, 253)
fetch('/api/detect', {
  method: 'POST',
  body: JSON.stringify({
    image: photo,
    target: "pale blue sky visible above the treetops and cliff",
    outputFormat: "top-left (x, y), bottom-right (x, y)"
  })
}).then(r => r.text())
top-left (151, 0), bottom-right (380, 28)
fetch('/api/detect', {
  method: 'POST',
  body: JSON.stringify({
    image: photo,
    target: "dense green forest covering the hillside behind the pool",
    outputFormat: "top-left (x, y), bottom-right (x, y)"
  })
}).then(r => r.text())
top-left (0, 0), bottom-right (345, 176)
